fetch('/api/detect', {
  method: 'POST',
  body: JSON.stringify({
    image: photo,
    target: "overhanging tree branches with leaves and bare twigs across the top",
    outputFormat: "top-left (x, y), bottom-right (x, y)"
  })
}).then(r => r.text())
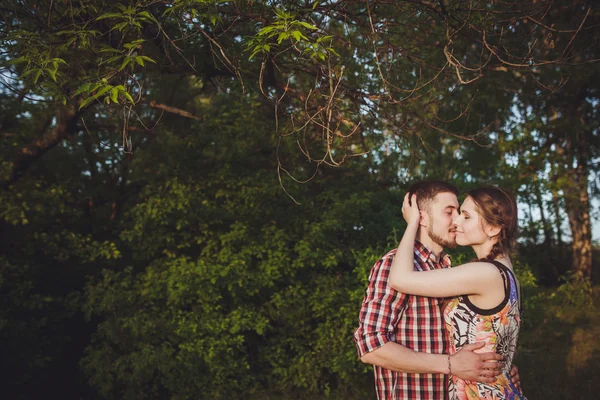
top-left (0, 0), bottom-right (592, 184)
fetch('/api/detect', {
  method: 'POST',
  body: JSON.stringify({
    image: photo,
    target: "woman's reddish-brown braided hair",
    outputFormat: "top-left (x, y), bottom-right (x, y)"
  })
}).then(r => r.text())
top-left (467, 186), bottom-right (518, 261)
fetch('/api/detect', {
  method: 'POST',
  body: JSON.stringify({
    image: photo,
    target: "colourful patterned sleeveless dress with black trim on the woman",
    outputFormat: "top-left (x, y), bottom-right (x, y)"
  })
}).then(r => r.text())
top-left (444, 261), bottom-right (526, 400)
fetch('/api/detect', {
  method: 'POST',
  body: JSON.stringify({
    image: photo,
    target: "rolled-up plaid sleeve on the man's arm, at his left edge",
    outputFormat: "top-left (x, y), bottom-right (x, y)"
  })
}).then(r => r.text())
top-left (354, 251), bottom-right (407, 357)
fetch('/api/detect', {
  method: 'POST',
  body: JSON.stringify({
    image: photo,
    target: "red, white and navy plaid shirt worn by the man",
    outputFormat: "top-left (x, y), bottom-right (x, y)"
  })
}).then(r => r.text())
top-left (354, 241), bottom-right (450, 400)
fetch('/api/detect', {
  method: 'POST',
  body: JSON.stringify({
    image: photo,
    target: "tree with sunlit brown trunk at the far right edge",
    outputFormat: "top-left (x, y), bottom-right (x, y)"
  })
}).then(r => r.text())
top-left (506, 2), bottom-right (599, 279)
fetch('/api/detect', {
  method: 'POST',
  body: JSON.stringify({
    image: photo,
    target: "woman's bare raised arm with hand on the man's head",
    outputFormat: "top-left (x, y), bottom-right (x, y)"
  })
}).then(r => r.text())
top-left (388, 194), bottom-right (502, 297)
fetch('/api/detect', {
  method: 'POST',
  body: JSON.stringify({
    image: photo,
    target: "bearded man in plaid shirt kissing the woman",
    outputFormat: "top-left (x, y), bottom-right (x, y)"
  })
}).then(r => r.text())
top-left (354, 181), bottom-right (519, 400)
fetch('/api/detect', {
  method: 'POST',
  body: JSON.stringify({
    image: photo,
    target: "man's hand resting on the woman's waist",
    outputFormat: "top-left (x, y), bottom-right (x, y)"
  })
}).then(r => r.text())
top-left (450, 342), bottom-right (504, 383)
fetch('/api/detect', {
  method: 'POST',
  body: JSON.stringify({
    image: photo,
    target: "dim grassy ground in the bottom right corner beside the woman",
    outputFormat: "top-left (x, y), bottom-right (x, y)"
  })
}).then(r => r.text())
top-left (515, 287), bottom-right (600, 400)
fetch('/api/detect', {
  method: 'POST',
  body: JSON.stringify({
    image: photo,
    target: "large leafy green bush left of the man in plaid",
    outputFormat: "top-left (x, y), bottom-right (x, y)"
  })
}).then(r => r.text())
top-left (75, 92), bottom-right (400, 399)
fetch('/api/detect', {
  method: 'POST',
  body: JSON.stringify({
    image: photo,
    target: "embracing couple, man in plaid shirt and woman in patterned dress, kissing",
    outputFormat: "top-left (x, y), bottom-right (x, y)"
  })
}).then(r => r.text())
top-left (354, 181), bottom-right (525, 400)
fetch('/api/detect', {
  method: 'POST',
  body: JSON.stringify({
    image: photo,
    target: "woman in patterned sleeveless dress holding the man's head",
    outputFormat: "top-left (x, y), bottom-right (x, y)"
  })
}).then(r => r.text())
top-left (388, 187), bottom-right (525, 400)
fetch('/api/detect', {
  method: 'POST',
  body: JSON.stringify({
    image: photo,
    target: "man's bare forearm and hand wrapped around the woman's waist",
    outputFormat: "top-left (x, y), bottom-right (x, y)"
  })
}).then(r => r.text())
top-left (360, 342), bottom-right (504, 383)
